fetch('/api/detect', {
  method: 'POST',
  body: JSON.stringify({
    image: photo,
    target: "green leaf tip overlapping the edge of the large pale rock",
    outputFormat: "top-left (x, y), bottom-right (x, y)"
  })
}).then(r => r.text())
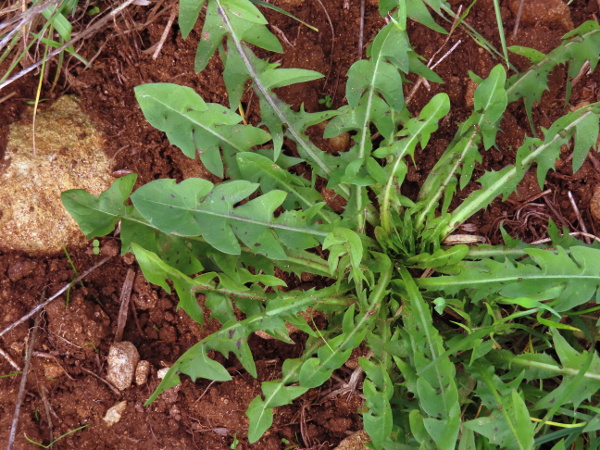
top-left (61, 174), bottom-right (137, 239)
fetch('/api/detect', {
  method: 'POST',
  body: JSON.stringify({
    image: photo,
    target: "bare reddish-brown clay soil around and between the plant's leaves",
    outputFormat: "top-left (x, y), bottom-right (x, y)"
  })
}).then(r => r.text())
top-left (0, 0), bottom-right (600, 449)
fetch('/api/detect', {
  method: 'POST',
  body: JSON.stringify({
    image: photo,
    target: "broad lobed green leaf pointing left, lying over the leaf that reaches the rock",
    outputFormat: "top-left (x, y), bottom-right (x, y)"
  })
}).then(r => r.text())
top-left (131, 179), bottom-right (326, 259)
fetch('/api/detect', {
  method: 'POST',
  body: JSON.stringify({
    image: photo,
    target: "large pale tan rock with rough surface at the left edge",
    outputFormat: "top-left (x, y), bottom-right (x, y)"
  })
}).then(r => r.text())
top-left (0, 96), bottom-right (113, 255)
